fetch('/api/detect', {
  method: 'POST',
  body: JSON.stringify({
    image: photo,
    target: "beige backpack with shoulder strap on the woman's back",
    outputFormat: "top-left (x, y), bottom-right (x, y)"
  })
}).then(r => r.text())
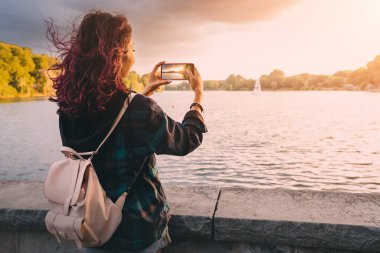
top-left (44, 93), bottom-right (134, 248)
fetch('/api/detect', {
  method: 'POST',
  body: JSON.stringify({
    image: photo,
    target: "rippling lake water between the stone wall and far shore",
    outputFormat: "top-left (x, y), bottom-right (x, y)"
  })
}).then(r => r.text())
top-left (0, 91), bottom-right (380, 192)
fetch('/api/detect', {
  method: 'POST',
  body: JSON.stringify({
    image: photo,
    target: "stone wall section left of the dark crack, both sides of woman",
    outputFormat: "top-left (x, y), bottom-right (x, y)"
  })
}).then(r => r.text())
top-left (0, 181), bottom-right (219, 239)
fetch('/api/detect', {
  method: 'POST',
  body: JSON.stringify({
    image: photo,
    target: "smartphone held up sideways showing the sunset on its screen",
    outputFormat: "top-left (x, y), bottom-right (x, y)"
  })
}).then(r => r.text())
top-left (161, 63), bottom-right (194, 80)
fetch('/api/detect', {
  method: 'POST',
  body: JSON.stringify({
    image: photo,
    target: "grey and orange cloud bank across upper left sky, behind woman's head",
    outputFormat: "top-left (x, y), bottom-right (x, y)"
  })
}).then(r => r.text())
top-left (0, 0), bottom-right (299, 57)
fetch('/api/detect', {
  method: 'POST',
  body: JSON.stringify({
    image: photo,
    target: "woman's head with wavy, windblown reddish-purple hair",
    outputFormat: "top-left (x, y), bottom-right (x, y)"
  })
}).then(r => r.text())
top-left (47, 11), bottom-right (135, 117)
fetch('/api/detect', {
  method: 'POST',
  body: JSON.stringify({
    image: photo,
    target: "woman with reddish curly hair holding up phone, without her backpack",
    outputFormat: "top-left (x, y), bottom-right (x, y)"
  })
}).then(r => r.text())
top-left (47, 11), bottom-right (206, 253)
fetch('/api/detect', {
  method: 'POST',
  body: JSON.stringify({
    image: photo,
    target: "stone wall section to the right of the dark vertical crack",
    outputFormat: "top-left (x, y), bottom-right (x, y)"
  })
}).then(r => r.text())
top-left (214, 188), bottom-right (380, 252)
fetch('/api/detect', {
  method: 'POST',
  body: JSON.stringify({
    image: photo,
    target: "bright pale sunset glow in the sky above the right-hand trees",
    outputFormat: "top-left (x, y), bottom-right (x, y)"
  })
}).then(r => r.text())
top-left (131, 0), bottom-right (380, 79)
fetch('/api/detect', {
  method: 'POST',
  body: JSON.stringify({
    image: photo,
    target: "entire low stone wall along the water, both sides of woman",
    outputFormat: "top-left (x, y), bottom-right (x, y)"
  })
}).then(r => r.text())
top-left (0, 181), bottom-right (380, 253)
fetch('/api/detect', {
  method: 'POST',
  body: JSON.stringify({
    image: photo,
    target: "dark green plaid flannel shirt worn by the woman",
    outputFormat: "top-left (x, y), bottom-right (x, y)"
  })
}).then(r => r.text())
top-left (93, 94), bottom-right (207, 251)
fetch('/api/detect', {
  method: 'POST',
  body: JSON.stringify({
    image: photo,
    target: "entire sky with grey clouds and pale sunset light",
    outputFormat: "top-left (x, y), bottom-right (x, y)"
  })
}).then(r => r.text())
top-left (0, 0), bottom-right (380, 80)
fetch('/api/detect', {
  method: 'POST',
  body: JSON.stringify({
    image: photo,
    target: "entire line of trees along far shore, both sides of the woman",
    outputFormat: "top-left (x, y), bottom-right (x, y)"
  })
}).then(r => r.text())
top-left (0, 41), bottom-right (380, 98)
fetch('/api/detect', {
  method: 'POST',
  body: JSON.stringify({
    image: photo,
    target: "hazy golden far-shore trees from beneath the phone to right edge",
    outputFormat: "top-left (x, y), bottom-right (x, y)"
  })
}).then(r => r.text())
top-left (165, 55), bottom-right (380, 91)
